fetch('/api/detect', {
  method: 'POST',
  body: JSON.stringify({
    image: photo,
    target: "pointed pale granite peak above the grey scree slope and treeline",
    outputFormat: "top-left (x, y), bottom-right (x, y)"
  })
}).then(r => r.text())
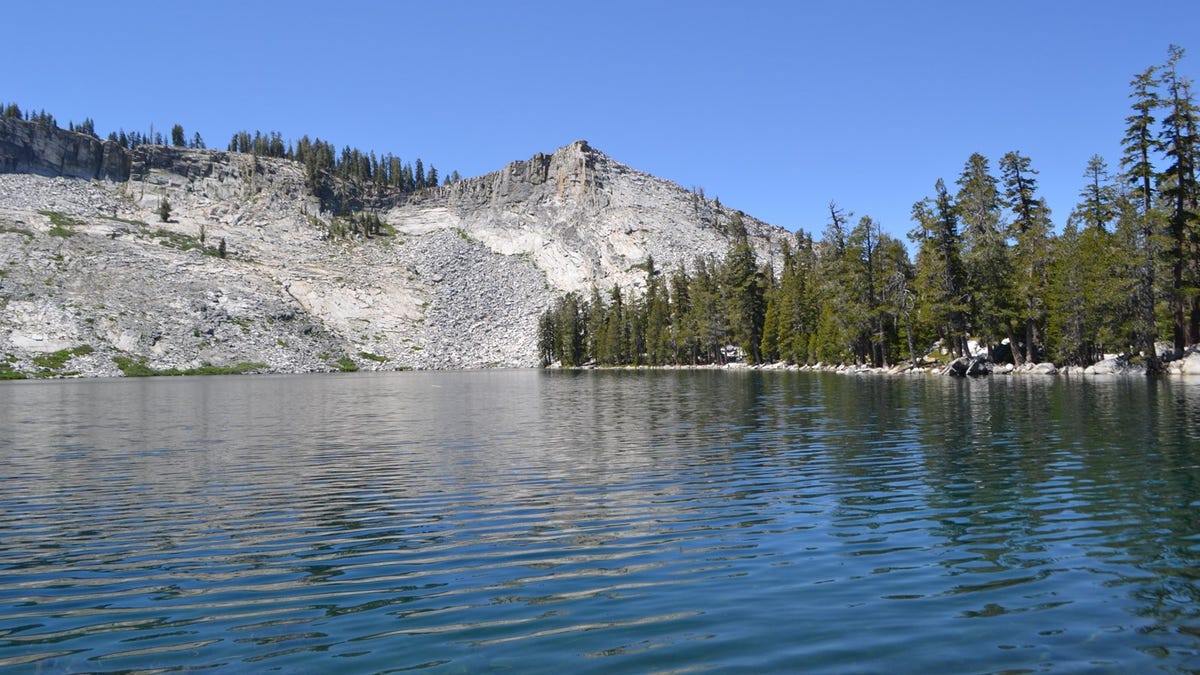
top-left (386, 141), bottom-right (788, 292)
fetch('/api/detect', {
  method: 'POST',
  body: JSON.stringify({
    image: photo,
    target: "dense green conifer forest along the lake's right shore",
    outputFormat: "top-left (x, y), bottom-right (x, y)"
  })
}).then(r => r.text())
top-left (538, 46), bottom-right (1200, 372)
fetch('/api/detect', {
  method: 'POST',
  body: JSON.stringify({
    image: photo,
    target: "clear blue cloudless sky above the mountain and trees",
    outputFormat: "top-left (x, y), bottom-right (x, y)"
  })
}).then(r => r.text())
top-left (0, 0), bottom-right (1200, 237)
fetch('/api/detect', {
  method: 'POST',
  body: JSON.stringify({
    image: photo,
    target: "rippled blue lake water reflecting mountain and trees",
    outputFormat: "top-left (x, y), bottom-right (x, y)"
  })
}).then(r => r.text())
top-left (0, 371), bottom-right (1200, 673)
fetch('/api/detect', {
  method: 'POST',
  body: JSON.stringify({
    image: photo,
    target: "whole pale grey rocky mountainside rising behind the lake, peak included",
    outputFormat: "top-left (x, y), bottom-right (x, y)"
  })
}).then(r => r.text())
top-left (0, 119), bottom-right (788, 376)
